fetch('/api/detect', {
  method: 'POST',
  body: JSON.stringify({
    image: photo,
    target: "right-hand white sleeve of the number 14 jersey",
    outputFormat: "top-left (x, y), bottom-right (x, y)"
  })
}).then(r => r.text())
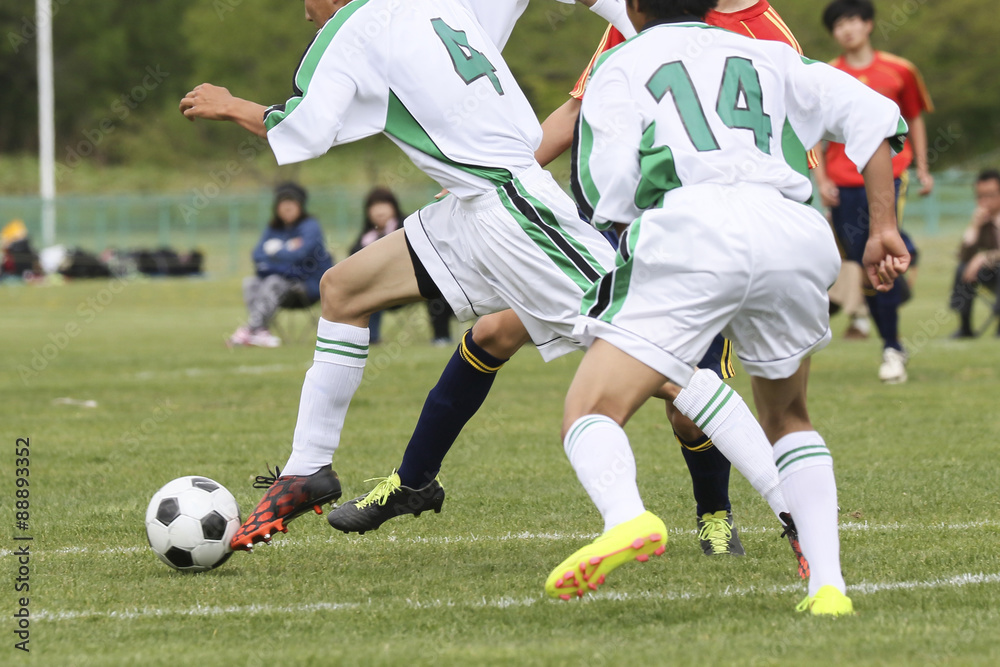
top-left (785, 54), bottom-right (907, 176)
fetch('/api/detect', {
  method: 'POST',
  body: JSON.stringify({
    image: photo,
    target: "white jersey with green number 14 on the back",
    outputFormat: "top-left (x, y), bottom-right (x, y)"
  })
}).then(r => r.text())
top-left (572, 21), bottom-right (906, 229)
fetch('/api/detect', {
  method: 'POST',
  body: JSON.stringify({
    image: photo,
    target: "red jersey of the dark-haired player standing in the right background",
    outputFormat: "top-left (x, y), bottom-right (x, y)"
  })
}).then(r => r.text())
top-left (826, 51), bottom-right (934, 188)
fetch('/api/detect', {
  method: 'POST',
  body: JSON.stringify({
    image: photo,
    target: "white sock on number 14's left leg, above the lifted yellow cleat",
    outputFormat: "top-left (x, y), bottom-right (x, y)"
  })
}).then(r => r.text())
top-left (563, 415), bottom-right (646, 532)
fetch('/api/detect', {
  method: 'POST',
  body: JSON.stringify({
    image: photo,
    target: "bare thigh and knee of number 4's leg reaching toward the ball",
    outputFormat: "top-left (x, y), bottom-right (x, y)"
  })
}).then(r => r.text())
top-left (320, 229), bottom-right (422, 323)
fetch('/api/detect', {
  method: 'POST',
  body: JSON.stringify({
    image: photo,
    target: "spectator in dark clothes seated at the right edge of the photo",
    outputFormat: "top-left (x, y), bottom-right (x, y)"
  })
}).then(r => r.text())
top-left (951, 169), bottom-right (1000, 338)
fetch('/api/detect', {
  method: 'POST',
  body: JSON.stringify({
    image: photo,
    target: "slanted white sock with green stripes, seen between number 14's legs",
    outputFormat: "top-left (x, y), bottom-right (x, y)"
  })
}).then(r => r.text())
top-left (674, 370), bottom-right (797, 525)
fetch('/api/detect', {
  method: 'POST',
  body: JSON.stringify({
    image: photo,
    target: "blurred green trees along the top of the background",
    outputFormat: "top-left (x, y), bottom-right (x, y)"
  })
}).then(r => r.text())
top-left (0, 0), bottom-right (1000, 168)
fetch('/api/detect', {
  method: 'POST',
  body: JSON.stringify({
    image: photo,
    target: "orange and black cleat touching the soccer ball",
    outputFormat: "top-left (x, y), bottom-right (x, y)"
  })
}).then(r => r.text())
top-left (229, 465), bottom-right (341, 551)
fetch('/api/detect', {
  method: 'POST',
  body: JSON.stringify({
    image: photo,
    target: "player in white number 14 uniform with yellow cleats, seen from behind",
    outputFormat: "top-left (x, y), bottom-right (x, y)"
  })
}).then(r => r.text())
top-left (546, 0), bottom-right (909, 615)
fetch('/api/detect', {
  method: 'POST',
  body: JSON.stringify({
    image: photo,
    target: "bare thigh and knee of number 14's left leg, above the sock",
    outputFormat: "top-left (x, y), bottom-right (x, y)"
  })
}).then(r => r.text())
top-left (563, 339), bottom-right (666, 437)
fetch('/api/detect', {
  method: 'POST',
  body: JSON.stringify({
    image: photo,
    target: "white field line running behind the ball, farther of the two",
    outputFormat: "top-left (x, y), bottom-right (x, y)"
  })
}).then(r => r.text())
top-left (0, 519), bottom-right (1000, 557)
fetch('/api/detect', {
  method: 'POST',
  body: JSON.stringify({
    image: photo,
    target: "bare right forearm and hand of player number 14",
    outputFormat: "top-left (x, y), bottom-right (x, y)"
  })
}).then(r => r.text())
top-left (861, 141), bottom-right (910, 292)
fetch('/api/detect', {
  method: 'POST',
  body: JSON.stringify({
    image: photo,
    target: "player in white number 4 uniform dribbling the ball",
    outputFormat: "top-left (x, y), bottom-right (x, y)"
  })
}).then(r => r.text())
top-left (180, 0), bottom-right (752, 549)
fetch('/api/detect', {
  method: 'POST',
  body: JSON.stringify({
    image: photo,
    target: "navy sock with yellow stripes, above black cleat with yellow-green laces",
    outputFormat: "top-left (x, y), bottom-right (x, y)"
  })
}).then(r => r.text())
top-left (397, 329), bottom-right (507, 489)
